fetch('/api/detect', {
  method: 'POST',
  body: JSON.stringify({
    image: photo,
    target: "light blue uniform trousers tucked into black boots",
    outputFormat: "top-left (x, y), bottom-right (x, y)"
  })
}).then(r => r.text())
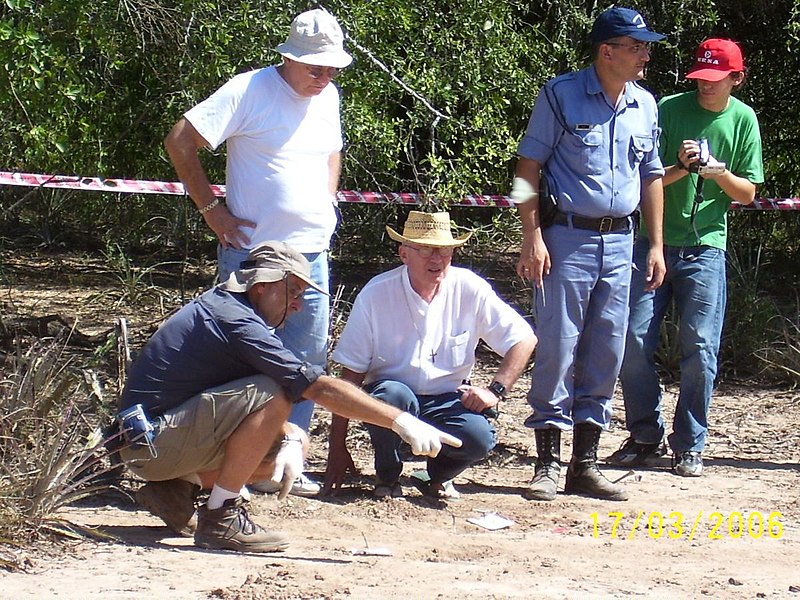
top-left (525, 225), bottom-right (633, 430)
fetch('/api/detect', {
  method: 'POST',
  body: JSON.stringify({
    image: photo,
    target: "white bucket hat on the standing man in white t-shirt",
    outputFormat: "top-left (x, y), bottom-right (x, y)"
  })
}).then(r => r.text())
top-left (275, 8), bottom-right (353, 69)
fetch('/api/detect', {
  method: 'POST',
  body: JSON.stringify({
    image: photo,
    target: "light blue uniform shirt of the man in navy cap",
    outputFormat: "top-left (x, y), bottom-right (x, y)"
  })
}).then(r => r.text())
top-left (518, 66), bottom-right (664, 218)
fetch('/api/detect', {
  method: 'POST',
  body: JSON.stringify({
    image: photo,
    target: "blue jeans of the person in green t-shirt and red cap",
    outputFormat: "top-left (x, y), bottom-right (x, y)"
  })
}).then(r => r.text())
top-left (621, 239), bottom-right (727, 454)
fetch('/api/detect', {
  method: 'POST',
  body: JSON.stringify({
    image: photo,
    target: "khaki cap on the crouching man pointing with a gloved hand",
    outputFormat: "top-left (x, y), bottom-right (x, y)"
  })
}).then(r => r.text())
top-left (219, 242), bottom-right (328, 296)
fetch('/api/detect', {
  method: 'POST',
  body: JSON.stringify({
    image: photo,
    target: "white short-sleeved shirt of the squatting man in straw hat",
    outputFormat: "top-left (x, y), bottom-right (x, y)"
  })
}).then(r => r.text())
top-left (333, 265), bottom-right (533, 395)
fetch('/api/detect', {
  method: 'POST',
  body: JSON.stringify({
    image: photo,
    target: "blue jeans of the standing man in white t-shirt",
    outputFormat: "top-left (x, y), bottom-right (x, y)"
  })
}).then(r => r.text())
top-left (217, 246), bottom-right (330, 431)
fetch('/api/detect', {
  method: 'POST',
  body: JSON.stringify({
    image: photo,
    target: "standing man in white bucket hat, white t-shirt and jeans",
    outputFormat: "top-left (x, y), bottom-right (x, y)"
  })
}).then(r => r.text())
top-left (165, 9), bottom-right (352, 495)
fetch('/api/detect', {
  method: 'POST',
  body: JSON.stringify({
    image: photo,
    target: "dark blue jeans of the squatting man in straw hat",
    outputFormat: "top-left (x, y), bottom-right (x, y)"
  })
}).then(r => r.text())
top-left (365, 380), bottom-right (497, 483)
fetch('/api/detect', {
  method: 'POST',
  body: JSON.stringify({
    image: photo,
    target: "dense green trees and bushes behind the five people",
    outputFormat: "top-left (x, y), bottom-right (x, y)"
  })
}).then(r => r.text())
top-left (0, 0), bottom-right (800, 379)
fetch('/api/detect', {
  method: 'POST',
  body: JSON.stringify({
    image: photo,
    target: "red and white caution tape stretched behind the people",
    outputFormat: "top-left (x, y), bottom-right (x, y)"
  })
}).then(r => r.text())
top-left (0, 171), bottom-right (800, 210)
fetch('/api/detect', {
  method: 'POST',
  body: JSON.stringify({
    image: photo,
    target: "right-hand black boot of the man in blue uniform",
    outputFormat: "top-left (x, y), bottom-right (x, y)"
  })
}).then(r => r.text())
top-left (564, 423), bottom-right (628, 500)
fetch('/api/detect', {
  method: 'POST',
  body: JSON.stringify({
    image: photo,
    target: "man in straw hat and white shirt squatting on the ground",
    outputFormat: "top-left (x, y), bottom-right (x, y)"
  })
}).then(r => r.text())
top-left (325, 211), bottom-right (536, 498)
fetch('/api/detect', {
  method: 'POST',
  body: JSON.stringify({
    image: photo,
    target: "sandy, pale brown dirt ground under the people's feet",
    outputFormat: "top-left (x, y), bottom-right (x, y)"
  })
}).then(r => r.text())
top-left (0, 251), bottom-right (800, 600)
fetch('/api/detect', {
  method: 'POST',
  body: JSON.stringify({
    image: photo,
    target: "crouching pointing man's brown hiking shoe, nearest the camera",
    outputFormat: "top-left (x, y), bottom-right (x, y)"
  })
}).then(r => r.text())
top-left (194, 497), bottom-right (289, 552)
